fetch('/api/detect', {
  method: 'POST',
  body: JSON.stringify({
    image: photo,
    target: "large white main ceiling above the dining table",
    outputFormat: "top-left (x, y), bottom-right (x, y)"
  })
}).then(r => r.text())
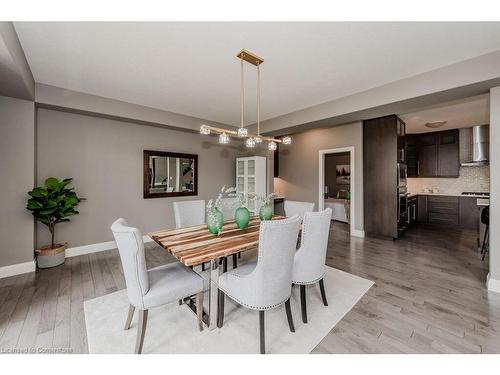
top-left (14, 22), bottom-right (500, 125)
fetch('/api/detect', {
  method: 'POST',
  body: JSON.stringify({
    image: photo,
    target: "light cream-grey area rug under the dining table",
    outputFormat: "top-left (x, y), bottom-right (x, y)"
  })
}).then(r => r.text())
top-left (84, 267), bottom-right (373, 354)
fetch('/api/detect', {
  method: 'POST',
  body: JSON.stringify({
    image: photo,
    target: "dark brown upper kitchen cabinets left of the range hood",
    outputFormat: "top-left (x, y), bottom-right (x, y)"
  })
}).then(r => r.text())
top-left (406, 129), bottom-right (460, 177)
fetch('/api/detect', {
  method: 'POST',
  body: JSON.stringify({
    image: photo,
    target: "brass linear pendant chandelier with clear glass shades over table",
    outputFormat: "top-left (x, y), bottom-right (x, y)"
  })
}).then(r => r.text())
top-left (200, 49), bottom-right (292, 151)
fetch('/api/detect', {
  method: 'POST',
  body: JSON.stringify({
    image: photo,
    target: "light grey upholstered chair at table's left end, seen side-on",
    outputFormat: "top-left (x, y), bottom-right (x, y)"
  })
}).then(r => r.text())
top-left (111, 218), bottom-right (203, 354)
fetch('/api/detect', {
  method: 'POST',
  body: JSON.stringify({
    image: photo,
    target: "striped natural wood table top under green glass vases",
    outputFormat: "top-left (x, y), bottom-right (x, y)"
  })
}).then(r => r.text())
top-left (148, 215), bottom-right (285, 266)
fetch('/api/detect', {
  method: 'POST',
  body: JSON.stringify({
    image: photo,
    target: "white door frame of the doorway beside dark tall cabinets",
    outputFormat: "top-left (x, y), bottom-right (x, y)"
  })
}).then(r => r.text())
top-left (318, 146), bottom-right (364, 237)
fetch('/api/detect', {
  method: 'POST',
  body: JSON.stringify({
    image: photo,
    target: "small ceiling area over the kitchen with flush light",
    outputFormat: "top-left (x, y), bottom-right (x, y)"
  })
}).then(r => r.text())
top-left (400, 94), bottom-right (490, 133)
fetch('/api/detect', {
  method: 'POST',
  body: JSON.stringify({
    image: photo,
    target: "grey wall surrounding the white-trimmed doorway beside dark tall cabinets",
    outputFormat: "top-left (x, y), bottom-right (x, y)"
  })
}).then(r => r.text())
top-left (274, 122), bottom-right (363, 230)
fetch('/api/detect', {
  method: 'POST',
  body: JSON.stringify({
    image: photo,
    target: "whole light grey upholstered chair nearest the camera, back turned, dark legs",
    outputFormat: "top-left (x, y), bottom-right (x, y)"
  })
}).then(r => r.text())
top-left (217, 216), bottom-right (300, 354)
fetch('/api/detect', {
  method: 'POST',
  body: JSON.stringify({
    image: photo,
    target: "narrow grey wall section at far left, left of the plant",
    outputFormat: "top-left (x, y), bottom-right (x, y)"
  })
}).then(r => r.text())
top-left (0, 96), bottom-right (35, 267)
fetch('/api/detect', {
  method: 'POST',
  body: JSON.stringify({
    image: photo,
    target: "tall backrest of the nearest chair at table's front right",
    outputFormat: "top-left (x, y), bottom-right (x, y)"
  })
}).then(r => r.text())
top-left (251, 216), bottom-right (300, 309)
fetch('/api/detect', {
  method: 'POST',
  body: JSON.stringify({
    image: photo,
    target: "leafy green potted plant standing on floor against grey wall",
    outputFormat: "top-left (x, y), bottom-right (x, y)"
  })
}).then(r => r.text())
top-left (26, 177), bottom-right (84, 268)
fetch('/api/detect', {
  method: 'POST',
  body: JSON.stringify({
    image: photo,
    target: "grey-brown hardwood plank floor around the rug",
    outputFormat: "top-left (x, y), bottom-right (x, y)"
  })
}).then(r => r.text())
top-left (0, 223), bottom-right (500, 353)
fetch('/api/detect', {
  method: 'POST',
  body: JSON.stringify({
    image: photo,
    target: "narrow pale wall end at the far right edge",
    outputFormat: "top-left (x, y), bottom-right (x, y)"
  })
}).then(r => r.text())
top-left (490, 87), bottom-right (500, 284)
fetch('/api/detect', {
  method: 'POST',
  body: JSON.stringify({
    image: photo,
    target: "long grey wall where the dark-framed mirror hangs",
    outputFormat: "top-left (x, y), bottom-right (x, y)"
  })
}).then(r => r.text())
top-left (37, 109), bottom-right (240, 247)
